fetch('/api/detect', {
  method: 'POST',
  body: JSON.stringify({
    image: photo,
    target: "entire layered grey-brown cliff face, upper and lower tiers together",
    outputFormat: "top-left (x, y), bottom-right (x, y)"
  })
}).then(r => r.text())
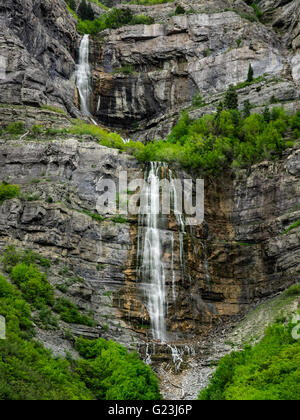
top-left (0, 0), bottom-right (300, 374)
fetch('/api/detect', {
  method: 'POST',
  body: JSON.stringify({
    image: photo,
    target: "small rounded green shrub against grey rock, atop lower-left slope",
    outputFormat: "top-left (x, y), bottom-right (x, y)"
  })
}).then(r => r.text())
top-left (11, 263), bottom-right (54, 308)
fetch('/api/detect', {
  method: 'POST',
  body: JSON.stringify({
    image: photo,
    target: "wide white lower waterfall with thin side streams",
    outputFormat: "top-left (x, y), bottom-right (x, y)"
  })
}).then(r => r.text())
top-left (137, 162), bottom-right (185, 342)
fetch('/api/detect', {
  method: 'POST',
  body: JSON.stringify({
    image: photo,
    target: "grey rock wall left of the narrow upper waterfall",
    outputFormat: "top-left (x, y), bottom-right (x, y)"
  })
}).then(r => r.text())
top-left (0, 0), bottom-right (79, 116)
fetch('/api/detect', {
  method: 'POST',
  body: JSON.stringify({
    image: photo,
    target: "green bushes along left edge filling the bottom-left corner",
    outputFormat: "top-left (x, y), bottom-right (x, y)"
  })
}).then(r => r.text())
top-left (0, 276), bottom-right (93, 401)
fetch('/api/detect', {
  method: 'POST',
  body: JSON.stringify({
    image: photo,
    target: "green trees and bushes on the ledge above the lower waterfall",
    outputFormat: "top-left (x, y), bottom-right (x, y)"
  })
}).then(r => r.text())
top-left (127, 108), bottom-right (300, 174)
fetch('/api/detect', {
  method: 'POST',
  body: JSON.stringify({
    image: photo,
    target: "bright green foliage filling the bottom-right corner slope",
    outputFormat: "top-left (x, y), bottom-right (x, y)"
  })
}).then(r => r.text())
top-left (199, 318), bottom-right (300, 400)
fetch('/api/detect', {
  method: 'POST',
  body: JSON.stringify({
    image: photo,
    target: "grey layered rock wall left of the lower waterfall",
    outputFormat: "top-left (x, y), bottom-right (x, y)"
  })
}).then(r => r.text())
top-left (0, 138), bottom-right (144, 348)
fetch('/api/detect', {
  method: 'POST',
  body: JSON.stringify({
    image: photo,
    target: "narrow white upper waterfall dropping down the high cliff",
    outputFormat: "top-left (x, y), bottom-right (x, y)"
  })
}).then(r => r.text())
top-left (76, 35), bottom-right (97, 125)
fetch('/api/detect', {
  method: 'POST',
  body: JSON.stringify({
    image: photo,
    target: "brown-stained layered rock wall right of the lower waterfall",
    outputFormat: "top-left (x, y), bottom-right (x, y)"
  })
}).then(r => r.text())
top-left (189, 149), bottom-right (300, 328)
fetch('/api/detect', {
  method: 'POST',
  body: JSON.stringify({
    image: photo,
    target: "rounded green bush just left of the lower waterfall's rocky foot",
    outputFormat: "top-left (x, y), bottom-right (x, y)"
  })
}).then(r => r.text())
top-left (75, 338), bottom-right (161, 400)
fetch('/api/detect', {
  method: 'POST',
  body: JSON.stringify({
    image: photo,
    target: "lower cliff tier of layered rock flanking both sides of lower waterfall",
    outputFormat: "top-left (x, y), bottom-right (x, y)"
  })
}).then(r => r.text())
top-left (0, 138), bottom-right (300, 346)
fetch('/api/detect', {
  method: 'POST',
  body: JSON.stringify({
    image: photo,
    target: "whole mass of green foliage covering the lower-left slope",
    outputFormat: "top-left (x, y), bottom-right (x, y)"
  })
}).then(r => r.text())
top-left (0, 247), bottom-right (160, 400)
